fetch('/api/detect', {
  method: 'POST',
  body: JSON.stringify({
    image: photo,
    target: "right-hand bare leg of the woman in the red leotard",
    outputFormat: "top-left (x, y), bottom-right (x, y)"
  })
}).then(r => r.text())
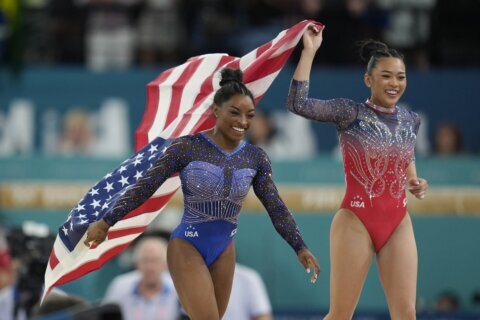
top-left (377, 214), bottom-right (418, 320)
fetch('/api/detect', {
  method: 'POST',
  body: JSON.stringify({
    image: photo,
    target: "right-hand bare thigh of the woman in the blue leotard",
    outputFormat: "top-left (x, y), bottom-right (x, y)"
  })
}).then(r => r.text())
top-left (210, 243), bottom-right (235, 318)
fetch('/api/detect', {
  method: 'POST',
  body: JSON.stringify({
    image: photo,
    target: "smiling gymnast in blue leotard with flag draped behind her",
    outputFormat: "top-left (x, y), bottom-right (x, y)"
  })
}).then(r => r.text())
top-left (86, 69), bottom-right (320, 319)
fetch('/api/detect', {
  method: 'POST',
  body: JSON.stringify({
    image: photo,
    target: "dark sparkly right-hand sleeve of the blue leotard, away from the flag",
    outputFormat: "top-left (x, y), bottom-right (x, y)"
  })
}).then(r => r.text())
top-left (252, 151), bottom-right (307, 253)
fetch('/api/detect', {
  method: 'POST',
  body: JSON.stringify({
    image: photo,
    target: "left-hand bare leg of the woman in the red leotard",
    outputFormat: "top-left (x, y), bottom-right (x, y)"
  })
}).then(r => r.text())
top-left (325, 209), bottom-right (375, 320)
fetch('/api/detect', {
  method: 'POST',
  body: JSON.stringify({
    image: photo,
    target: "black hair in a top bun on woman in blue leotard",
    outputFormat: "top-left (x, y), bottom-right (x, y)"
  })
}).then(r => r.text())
top-left (213, 68), bottom-right (255, 106)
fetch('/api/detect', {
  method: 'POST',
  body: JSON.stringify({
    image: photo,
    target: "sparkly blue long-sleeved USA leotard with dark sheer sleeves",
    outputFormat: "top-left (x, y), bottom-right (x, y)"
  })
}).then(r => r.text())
top-left (103, 133), bottom-right (306, 266)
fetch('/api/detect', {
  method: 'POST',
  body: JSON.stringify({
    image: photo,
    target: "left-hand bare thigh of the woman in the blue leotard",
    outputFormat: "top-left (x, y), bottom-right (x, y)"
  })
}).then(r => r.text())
top-left (167, 238), bottom-right (220, 320)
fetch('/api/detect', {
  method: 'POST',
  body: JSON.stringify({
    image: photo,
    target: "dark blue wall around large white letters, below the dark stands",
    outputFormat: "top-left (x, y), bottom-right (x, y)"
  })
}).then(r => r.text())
top-left (0, 65), bottom-right (480, 152)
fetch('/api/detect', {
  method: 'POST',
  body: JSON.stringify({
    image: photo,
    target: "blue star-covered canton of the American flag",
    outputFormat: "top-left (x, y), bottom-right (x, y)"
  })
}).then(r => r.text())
top-left (58, 138), bottom-right (172, 251)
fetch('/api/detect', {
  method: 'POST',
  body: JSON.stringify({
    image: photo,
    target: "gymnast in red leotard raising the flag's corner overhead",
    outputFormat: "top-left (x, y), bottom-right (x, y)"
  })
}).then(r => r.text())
top-left (287, 25), bottom-right (428, 320)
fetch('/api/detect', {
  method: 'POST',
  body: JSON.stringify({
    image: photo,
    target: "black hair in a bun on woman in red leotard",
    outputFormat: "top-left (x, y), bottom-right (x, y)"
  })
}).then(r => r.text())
top-left (358, 39), bottom-right (403, 74)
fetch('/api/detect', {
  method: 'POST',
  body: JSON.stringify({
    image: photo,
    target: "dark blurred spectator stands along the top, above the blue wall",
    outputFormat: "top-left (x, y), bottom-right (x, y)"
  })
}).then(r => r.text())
top-left (0, 0), bottom-right (480, 70)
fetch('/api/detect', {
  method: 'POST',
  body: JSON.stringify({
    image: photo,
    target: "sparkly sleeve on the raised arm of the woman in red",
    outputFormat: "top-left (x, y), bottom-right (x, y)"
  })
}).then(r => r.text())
top-left (287, 79), bottom-right (358, 129)
